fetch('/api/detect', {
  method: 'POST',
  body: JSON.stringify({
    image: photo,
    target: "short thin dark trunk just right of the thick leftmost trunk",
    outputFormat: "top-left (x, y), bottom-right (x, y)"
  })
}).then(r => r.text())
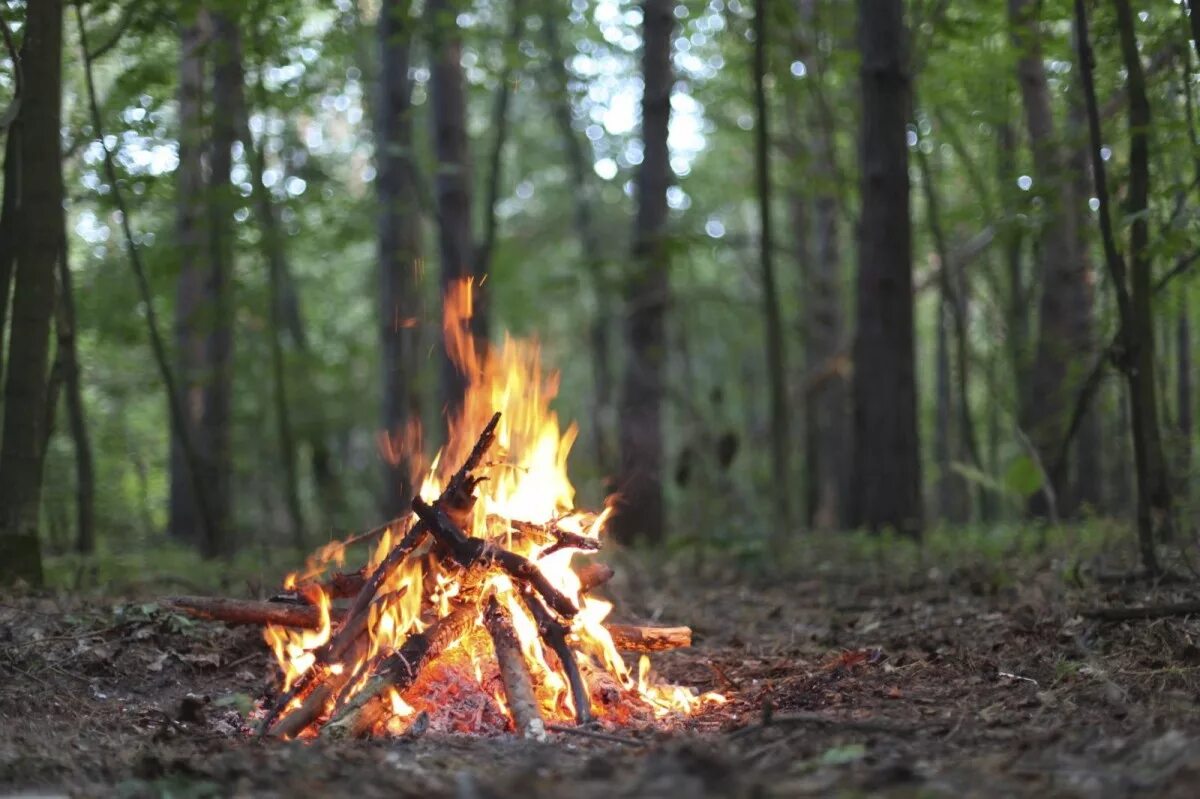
top-left (55, 224), bottom-right (96, 554)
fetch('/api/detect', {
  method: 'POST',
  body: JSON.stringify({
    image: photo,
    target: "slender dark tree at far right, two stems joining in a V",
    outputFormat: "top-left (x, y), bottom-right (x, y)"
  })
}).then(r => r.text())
top-left (1075, 0), bottom-right (1172, 573)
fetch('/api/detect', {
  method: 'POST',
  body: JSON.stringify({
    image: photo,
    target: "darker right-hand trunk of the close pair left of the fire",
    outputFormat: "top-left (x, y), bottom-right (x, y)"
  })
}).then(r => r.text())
top-left (200, 13), bottom-right (245, 558)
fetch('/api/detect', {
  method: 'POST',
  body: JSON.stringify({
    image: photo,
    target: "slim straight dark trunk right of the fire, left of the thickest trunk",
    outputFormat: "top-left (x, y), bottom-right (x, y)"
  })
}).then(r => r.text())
top-left (754, 0), bottom-right (794, 537)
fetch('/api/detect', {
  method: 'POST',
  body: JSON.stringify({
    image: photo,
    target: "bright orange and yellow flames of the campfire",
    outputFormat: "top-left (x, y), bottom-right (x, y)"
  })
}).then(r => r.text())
top-left (265, 281), bottom-right (724, 733)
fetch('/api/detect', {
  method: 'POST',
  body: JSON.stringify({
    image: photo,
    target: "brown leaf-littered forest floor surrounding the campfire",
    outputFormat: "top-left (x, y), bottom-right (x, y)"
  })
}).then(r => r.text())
top-left (0, 525), bottom-right (1200, 799)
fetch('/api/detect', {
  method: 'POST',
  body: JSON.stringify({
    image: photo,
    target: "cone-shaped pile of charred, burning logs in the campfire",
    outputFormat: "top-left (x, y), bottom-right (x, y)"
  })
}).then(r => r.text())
top-left (163, 413), bottom-right (701, 739)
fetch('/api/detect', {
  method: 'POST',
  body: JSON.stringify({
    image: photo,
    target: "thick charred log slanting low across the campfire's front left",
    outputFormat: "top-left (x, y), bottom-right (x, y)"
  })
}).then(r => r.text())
top-left (322, 607), bottom-right (475, 738)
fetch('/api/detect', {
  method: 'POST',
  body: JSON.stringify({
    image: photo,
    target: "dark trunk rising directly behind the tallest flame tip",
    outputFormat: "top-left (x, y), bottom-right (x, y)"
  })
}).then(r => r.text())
top-left (426, 0), bottom-right (472, 417)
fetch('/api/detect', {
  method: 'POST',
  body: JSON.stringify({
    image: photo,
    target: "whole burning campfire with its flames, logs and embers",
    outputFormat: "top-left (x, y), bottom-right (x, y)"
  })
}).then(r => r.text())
top-left (172, 283), bottom-right (722, 738)
